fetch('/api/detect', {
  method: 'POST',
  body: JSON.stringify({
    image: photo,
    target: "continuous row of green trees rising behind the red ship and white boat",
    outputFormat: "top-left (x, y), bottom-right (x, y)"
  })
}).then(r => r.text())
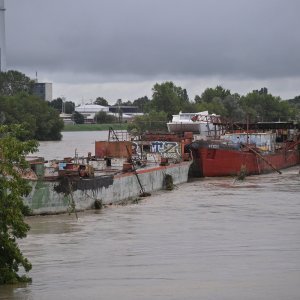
top-left (129, 82), bottom-right (300, 132)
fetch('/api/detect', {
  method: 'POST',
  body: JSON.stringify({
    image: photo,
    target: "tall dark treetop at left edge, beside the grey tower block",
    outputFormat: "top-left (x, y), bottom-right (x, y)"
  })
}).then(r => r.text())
top-left (0, 70), bottom-right (34, 96)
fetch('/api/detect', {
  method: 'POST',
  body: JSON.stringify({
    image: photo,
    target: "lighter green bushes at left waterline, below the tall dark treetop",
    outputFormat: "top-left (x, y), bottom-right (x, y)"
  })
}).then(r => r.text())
top-left (0, 93), bottom-right (63, 141)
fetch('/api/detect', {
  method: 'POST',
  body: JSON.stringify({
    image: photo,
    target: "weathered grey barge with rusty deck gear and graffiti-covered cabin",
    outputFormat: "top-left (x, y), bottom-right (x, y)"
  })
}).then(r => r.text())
top-left (23, 130), bottom-right (192, 214)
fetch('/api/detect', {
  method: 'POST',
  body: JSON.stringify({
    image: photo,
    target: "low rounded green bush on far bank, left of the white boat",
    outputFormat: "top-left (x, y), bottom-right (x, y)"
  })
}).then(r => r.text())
top-left (128, 111), bottom-right (168, 134)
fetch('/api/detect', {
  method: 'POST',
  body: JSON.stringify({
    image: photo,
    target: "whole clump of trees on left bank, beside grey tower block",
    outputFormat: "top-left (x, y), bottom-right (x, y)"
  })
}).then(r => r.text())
top-left (0, 70), bottom-right (64, 141)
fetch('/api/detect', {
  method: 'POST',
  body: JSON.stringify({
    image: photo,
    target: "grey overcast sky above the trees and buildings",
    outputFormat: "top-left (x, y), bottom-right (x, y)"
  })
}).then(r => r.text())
top-left (5, 0), bottom-right (300, 104)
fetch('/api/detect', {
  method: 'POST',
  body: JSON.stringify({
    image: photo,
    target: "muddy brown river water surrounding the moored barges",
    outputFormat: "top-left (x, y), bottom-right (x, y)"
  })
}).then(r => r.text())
top-left (0, 132), bottom-right (300, 300)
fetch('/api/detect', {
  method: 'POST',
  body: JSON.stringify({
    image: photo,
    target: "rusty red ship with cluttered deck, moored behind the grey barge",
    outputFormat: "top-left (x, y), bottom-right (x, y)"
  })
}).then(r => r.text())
top-left (189, 123), bottom-right (300, 177)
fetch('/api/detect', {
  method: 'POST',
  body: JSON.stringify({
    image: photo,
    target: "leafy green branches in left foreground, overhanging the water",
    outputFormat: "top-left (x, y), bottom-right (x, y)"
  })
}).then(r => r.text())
top-left (0, 125), bottom-right (37, 284)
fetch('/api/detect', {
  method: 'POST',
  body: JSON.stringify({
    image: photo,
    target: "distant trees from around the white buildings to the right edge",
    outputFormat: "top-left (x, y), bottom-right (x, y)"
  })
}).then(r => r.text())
top-left (52, 82), bottom-right (300, 127)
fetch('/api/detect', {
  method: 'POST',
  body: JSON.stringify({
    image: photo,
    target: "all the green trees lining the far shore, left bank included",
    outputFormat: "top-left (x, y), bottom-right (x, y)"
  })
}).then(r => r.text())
top-left (0, 71), bottom-right (300, 140)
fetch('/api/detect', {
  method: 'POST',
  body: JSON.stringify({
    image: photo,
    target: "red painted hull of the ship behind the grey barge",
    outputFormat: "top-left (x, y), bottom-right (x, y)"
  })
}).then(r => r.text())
top-left (192, 142), bottom-right (299, 177)
